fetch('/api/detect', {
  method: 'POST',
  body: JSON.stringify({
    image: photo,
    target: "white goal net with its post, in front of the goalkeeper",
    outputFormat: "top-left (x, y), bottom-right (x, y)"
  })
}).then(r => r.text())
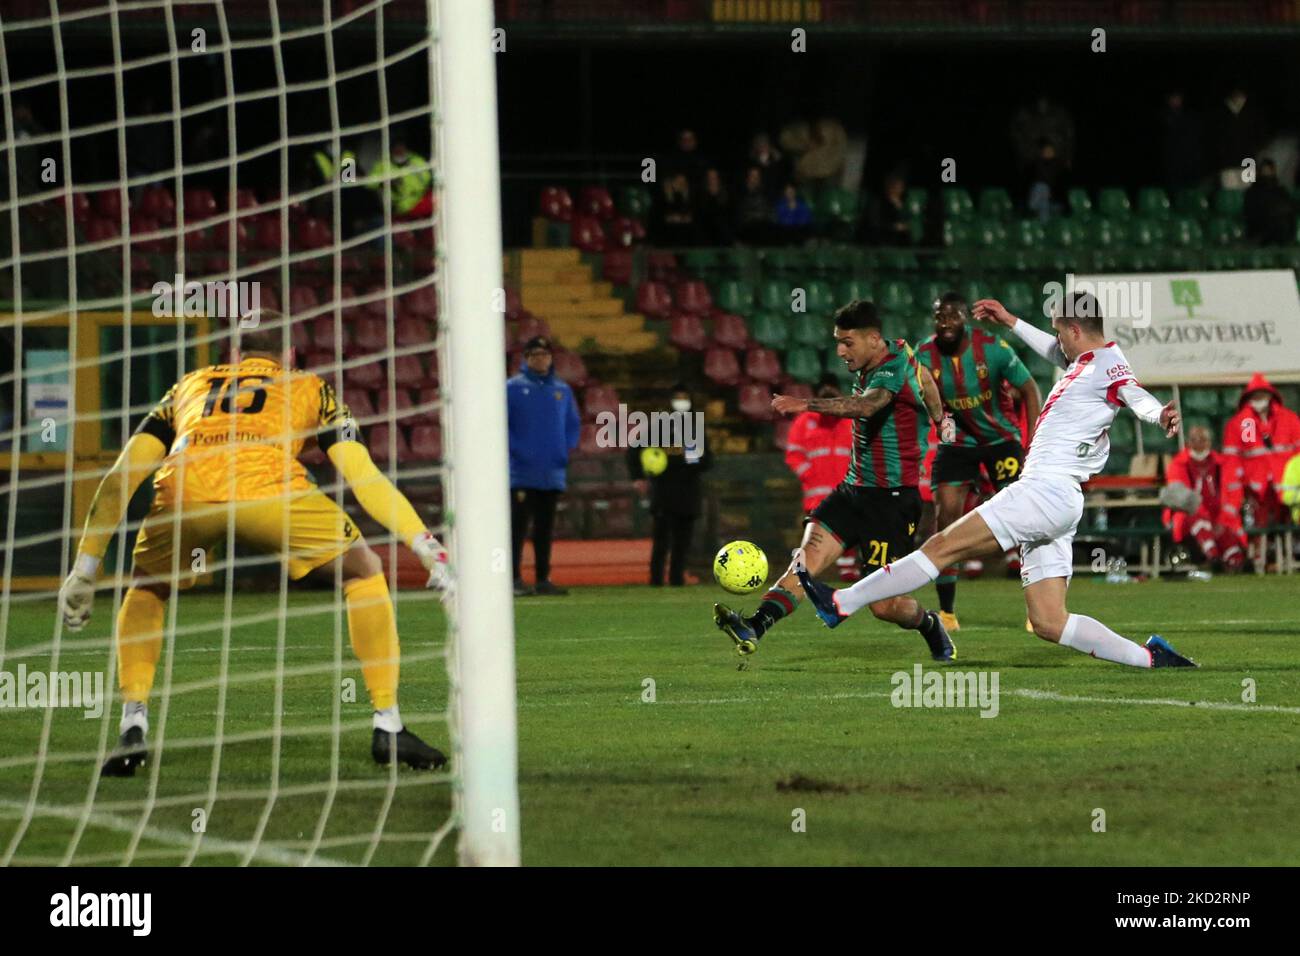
top-left (0, 0), bottom-right (519, 865)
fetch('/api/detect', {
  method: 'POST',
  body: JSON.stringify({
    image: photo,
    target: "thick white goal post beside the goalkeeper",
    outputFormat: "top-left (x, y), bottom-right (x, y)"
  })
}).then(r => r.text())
top-left (429, 0), bottom-right (520, 866)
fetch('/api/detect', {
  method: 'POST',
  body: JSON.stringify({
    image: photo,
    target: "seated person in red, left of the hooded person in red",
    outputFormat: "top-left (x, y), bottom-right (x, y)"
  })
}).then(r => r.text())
top-left (1164, 425), bottom-right (1245, 571)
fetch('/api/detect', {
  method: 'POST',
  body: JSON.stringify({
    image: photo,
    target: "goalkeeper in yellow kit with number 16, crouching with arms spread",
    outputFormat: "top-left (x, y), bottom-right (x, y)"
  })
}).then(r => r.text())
top-left (59, 311), bottom-right (450, 777)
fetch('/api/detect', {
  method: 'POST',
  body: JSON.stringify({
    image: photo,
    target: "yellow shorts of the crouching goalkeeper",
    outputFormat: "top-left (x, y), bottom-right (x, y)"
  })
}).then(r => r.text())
top-left (131, 488), bottom-right (360, 588)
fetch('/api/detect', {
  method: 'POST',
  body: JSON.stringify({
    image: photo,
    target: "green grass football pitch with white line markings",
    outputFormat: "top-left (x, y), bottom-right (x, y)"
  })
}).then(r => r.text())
top-left (0, 578), bottom-right (1300, 865)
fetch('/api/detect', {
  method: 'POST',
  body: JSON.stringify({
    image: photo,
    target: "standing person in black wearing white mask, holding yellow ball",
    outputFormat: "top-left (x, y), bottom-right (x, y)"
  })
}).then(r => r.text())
top-left (628, 385), bottom-right (711, 588)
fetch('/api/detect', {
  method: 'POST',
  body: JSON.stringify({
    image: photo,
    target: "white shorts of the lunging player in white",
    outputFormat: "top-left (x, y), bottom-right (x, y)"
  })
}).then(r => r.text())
top-left (975, 477), bottom-right (1083, 587)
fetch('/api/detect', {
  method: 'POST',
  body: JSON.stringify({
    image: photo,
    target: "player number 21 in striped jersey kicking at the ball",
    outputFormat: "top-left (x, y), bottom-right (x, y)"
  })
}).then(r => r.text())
top-left (714, 300), bottom-right (956, 661)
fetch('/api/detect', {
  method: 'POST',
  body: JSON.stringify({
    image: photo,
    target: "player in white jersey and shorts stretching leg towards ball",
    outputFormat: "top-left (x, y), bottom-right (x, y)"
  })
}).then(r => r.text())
top-left (800, 293), bottom-right (1196, 667)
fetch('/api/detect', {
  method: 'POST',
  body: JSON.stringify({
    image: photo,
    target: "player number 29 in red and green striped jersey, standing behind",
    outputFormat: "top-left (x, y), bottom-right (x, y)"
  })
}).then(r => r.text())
top-left (917, 293), bottom-right (1041, 631)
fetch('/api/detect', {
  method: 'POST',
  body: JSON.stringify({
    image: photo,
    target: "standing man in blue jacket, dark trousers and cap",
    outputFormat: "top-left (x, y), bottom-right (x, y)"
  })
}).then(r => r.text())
top-left (506, 336), bottom-right (582, 597)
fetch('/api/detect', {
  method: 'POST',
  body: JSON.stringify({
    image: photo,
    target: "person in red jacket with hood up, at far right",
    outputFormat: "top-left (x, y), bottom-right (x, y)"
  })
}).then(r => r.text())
top-left (1223, 373), bottom-right (1300, 527)
